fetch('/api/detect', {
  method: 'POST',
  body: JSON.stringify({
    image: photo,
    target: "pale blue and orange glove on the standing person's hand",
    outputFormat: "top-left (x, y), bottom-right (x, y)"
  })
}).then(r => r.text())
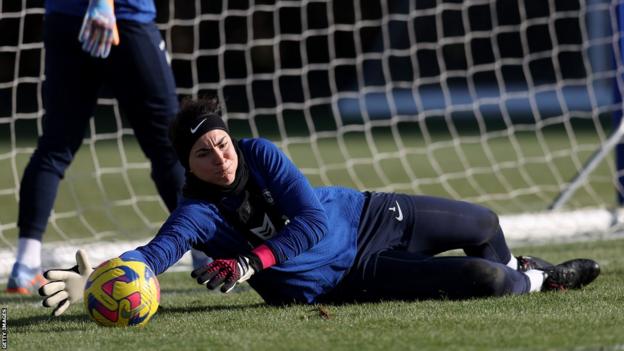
top-left (78, 0), bottom-right (119, 58)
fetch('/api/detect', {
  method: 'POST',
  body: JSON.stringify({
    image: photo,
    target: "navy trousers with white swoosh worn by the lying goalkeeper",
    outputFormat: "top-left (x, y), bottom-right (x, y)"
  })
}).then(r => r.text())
top-left (321, 193), bottom-right (529, 302)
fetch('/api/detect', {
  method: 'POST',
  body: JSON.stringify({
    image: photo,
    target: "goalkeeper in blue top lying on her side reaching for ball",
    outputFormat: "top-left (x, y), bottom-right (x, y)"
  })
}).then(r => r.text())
top-left (40, 99), bottom-right (600, 315)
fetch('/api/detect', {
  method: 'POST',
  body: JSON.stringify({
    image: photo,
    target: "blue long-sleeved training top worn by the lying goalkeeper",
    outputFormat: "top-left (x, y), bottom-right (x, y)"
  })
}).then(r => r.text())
top-left (125, 139), bottom-right (365, 303)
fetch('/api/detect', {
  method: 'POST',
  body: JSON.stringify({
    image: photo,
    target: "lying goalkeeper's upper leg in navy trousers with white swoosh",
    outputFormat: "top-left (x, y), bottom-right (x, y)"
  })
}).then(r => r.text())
top-left (356, 193), bottom-right (512, 264)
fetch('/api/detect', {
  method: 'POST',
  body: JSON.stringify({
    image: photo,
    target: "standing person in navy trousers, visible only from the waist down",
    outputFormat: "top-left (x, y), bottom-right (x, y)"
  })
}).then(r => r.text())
top-left (7, 0), bottom-right (190, 294)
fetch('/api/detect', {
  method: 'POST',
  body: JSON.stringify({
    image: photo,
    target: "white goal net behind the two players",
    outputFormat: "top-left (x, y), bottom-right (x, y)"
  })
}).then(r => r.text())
top-left (0, 0), bottom-right (623, 273)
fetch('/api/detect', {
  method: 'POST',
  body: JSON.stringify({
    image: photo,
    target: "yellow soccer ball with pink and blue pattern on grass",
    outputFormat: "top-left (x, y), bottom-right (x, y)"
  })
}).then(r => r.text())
top-left (84, 257), bottom-right (160, 327)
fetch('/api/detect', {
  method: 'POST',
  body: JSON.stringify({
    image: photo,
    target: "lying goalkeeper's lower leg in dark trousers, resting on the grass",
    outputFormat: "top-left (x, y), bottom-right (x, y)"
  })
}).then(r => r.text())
top-left (357, 250), bottom-right (530, 300)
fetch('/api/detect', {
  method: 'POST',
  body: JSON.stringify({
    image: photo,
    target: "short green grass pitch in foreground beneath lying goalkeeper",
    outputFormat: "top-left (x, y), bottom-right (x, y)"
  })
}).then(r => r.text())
top-left (0, 238), bottom-right (624, 351)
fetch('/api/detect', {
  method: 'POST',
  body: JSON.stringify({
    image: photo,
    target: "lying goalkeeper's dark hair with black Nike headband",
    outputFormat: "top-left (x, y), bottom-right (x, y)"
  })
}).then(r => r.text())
top-left (169, 97), bottom-right (229, 170)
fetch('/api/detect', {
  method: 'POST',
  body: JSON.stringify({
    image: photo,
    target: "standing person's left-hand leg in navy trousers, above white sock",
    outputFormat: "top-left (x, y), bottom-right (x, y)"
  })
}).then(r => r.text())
top-left (18, 14), bottom-right (102, 241)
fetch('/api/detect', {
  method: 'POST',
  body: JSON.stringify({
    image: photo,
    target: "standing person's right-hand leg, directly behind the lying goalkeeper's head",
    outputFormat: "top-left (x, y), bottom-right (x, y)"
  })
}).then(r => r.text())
top-left (109, 21), bottom-right (184, 211)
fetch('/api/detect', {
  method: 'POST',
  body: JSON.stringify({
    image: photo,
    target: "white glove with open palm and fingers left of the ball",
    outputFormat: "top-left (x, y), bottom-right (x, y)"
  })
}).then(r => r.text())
top-left (39, 250), bottom-right (93, 317)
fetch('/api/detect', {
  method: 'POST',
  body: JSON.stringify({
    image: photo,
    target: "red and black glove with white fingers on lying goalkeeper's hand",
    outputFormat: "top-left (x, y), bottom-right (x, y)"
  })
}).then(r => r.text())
top-left (191, 245), bottom-right (275, 293)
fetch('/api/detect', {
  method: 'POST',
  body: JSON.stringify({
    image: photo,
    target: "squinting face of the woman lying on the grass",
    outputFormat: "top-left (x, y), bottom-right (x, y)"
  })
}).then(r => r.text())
top-left (189, 129), bottom-right (238, 186)
